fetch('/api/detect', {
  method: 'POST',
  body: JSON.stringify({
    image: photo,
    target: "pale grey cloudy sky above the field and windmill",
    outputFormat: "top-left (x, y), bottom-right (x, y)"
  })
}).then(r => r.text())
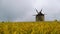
top-left (0, 0), bottom-right (60, 21)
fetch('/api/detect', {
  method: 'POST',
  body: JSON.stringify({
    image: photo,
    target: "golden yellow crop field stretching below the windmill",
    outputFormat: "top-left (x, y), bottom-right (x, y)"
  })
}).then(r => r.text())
top-left (0, 21), bottom-right (60, 34)
